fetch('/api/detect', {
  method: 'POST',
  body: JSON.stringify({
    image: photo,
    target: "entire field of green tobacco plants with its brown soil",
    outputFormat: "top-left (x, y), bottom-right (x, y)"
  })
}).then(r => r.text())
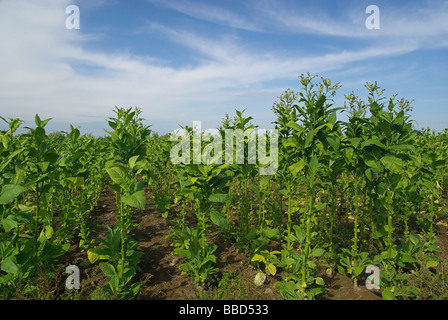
top-left (0, 74), bottom-right (448, 300)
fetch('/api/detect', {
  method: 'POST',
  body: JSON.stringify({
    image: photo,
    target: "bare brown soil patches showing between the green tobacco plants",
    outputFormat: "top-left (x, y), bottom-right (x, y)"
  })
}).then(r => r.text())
top-left (60, 185), bottom-right (448, 300)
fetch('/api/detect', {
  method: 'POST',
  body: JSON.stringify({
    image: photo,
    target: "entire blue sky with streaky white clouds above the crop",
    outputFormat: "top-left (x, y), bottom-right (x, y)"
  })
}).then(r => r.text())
top-left (0, 0), bottom-right (448, 135)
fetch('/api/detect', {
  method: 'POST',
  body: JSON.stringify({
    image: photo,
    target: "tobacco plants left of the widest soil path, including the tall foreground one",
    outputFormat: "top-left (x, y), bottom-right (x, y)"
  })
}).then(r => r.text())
top-left (0, 108), bottom-right (161, 299)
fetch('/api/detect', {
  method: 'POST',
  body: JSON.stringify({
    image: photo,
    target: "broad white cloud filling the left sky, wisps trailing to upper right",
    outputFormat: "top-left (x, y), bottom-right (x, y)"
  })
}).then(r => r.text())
top-left (0, 0), bottom-right (444, 135)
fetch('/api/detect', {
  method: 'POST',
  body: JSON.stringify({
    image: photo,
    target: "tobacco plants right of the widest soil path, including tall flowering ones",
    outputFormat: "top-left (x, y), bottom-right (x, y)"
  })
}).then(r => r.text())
top-left (164, 74), bottom-right (448, 299)
